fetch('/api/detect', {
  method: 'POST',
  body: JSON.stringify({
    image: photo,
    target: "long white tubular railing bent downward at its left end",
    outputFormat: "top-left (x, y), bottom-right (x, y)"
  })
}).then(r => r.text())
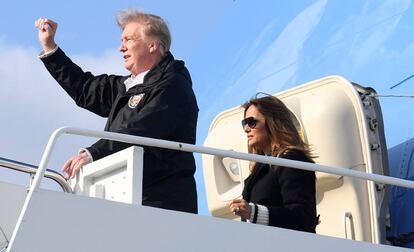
top-left (6, 127), bottom-right (414, 252)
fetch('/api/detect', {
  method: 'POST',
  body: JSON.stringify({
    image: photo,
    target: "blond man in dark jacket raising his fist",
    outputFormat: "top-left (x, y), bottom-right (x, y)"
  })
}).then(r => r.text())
top-left (35, 9), bottom-right (198, 213)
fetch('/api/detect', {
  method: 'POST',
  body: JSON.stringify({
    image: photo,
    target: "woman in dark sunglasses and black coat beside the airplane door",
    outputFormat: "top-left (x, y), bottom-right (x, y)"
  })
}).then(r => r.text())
top-left (229, 96), bottom-right (318, 233)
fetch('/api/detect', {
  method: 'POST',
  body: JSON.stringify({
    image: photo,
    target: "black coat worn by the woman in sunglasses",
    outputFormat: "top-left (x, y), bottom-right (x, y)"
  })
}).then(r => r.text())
top-left (243, 149), bottom-right (318, 233)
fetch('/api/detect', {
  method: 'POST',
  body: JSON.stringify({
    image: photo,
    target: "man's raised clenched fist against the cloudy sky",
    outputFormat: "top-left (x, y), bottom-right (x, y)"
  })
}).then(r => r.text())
top-left (35, 18), bottom-right (57, 53)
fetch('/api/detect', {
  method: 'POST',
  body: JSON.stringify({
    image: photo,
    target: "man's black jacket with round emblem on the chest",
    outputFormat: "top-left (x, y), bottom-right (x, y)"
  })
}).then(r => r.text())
top-left (42, 49), bottom-right (198, 213)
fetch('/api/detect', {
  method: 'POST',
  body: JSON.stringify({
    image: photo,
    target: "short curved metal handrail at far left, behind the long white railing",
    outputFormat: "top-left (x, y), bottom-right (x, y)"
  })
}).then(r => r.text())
top-left (0, 157), bottom-right (72, 193)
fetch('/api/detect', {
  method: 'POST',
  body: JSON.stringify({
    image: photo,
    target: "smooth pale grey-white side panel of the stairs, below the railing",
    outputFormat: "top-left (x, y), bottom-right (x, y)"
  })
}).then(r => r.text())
top-left (10, 189), bottom-right (411, 252)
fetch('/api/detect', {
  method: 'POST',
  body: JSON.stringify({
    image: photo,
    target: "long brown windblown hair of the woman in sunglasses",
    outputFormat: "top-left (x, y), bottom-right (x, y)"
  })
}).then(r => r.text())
top-left (242, 95), bottom-right (313, 167)
